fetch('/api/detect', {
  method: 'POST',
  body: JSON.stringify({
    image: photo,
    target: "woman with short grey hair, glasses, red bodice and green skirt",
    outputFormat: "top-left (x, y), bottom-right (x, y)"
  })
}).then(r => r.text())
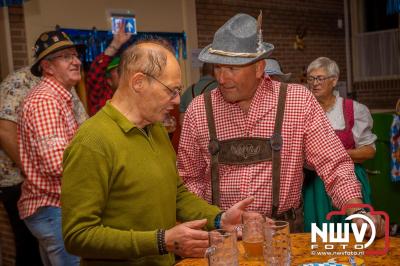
top-left (303, 57), bottom-right (377, 231)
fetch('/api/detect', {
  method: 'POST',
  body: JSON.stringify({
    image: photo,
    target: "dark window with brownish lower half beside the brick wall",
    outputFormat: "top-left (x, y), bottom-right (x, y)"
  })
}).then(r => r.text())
top-left (347, 0), bottom-right (400, 81)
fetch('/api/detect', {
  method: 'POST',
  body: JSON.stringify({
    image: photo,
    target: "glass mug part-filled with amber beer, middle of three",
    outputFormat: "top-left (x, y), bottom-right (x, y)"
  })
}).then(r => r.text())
top-left (241, 211), bottom-right (265, 260)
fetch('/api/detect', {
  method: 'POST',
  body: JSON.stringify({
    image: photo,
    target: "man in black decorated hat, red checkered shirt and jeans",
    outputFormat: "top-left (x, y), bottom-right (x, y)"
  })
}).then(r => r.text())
top-left (18, 31), bottom-right (85, 266)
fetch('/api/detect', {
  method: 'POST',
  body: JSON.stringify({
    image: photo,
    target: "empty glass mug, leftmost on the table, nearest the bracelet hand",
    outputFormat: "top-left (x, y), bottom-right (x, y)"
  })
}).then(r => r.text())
top-left (205, 229), bottom-right (239, 266)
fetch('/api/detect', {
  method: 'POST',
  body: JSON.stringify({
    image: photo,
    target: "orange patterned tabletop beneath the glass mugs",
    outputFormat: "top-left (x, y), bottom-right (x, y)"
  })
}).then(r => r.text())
top-left (176, 233), bottom-right (400, 266)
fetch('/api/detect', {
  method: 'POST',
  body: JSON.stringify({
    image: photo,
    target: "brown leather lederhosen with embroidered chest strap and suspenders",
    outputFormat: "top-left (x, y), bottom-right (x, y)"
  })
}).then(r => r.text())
top-left (204, 83), bottom-right (304, 232)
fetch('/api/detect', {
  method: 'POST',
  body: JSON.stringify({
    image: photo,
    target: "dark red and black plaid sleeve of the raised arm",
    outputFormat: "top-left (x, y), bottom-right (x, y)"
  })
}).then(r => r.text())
top-left (86, 53), bottom-right (113, 116)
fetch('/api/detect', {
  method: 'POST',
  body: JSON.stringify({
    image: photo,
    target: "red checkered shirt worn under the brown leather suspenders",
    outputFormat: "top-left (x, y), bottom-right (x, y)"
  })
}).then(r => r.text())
top-left (178, 78), bottom-right (361, 216)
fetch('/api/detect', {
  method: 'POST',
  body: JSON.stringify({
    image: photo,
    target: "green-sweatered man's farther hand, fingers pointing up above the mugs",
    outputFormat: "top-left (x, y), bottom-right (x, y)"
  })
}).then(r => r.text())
top-left (221, 197), bottom-right (254, 231)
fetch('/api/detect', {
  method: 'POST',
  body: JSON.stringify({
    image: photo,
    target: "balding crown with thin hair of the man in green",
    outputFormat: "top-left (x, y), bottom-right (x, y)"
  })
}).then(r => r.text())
top-left (118, 39), bottom-right (174, 79)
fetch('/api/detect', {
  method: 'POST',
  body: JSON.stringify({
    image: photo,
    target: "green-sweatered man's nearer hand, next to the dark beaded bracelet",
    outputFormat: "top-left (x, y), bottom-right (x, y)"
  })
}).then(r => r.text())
top-left (165, 219), bottom-right (208, 257)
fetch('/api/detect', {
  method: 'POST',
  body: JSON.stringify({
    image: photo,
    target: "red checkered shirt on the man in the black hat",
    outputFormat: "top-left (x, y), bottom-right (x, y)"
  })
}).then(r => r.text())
top-left (18, 78), bottom-right (78, 219)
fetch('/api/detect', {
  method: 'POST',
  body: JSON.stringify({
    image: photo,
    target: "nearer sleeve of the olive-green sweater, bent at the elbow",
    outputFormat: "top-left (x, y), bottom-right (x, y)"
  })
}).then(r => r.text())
top-left (61, 142), bottom-right (158, 260)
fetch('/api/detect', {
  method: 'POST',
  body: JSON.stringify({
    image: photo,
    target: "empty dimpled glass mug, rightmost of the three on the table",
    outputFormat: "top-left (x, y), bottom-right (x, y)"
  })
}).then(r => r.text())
top-left (264, 221), bottom-right (291, 266)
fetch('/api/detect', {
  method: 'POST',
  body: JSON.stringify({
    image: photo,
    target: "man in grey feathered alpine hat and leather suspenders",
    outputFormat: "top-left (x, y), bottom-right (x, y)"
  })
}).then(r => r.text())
top-left (178, 14), bottom-right (384, 236)
